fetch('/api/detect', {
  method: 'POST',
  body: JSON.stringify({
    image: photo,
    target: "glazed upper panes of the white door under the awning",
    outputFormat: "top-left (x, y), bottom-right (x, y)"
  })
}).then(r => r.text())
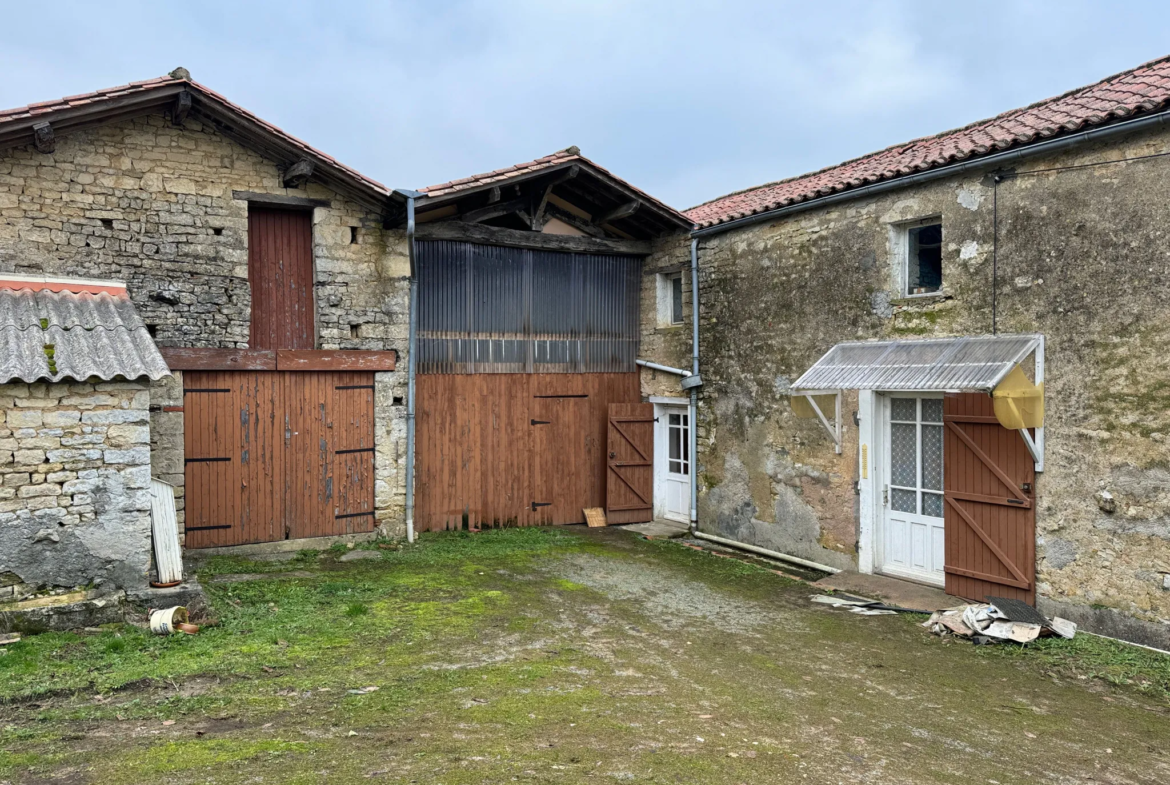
top-left (889, 398), bottom-right (943, 518)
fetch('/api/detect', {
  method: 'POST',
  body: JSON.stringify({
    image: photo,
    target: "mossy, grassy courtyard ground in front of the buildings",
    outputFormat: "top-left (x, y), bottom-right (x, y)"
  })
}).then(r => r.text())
top-left (0, 529), bottom-right (1170, 784)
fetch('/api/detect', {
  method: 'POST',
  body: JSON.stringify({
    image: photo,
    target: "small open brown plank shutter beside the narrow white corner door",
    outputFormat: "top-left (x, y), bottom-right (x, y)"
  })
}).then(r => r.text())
top-left (605, 404), bottom-right (654, 523)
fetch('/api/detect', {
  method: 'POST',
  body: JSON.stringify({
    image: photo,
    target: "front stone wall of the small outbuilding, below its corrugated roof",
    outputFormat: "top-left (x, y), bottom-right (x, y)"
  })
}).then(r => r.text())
top-left (0, 380), bottom-right (151, 591)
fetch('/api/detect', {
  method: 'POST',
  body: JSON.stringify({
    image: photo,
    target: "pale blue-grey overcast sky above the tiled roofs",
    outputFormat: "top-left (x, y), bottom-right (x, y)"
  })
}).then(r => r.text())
top-left (0, 0), bottom-right (1170, 208)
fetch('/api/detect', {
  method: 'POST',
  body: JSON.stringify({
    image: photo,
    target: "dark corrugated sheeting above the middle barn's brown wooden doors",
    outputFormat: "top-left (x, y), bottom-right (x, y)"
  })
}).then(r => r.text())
top-left (418, 240), bottom-right (641, 373)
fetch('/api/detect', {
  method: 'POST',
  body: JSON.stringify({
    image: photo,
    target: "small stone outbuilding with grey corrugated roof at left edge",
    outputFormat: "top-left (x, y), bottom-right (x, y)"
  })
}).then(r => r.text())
top-left (0, 274), bottom-right (171, 615)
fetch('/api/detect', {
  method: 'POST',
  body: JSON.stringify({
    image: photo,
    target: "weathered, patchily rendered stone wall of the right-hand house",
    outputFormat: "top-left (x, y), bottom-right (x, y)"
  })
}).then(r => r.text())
top-left (700, 122), bottom-right (1170, 629)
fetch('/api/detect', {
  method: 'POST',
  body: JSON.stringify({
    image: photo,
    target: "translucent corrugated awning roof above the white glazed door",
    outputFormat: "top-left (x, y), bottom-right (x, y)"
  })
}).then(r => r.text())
top-left (792, 335), bottom-right (1041, 394)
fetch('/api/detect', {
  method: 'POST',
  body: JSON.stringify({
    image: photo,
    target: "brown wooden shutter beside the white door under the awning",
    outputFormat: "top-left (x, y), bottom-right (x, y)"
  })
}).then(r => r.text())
top-left (943, 393), bottom-right (1035, 605)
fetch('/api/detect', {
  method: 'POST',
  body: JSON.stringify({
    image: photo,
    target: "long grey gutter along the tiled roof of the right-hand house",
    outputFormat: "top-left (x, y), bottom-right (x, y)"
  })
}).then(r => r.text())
top-left (690, 110), bottom-right (1170, 237)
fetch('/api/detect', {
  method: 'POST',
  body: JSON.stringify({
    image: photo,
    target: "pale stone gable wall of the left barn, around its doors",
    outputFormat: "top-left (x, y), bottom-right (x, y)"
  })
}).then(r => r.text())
top-left (0, 113), bottom-right (410, 531)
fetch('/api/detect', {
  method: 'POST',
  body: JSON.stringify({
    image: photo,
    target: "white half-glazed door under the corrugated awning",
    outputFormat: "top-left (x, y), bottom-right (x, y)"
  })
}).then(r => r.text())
top-left (880, 394), bottom-right (945, 586)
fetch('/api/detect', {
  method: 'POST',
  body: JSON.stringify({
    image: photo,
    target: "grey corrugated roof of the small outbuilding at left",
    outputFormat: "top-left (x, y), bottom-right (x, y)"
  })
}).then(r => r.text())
top-left (0, 289), bottom-right (171, 384)
